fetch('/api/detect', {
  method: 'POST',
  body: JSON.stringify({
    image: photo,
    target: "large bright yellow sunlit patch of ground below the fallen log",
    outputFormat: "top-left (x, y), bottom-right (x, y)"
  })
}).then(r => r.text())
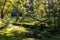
top-left (0, 24), bottom-right (29, 36)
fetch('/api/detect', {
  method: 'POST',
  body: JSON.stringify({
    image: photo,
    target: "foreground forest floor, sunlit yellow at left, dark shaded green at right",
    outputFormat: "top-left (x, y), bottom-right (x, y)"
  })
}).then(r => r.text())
top-left (0, 20), bottom-right (60, 40)
